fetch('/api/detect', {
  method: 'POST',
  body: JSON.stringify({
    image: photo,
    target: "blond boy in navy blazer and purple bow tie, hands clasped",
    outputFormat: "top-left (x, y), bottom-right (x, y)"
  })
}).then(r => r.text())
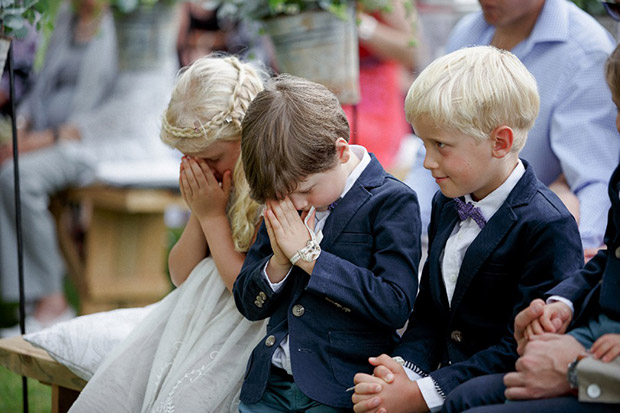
top-left (353, 46), bottom-right (583, 413)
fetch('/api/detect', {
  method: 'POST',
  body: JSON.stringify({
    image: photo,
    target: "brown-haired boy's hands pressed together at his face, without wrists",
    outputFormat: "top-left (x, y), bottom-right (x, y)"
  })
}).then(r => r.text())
top-left (265, 197), bottom-right (314, 261)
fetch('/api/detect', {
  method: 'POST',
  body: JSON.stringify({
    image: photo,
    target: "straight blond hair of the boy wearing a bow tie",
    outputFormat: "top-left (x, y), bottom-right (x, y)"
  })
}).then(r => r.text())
top-left (405, 46), bottom-right (539, 153)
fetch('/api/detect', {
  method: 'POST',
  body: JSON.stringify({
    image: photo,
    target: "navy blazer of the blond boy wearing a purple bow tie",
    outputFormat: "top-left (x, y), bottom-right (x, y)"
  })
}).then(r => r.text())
top-left (393, 161), bottom-right (583, 394)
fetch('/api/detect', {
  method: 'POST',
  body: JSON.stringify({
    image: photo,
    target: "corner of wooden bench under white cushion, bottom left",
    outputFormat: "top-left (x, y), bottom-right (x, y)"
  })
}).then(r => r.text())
top-left (0, 336), bottom-right (86, 413)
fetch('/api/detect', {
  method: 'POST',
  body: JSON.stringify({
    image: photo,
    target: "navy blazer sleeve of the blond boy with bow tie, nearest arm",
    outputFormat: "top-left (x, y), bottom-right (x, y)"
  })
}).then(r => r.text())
top-left (431, 209), bottom-right (583, 394)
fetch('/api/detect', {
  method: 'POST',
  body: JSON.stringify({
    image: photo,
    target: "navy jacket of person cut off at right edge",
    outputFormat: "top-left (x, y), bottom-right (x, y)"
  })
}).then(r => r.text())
top-left (548, 165), bottom-right (620, 326)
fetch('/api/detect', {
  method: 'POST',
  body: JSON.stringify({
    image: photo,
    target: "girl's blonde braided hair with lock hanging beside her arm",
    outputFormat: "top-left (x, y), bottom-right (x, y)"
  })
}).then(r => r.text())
top-left (160, 55), bottom-right (267, 252)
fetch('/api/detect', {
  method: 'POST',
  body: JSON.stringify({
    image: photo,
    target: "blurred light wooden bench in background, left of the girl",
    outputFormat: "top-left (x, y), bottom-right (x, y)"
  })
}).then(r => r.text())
top-left (51, 186), bottom-right (185, 314)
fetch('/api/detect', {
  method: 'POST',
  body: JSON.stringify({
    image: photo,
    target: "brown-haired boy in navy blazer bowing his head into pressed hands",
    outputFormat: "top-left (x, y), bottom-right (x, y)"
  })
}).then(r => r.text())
top-left (233, 76), bottom-right (420, 412)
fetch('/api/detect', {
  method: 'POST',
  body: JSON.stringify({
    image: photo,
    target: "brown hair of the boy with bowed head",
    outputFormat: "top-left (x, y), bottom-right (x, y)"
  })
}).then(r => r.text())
top-left (241, 75), bottom-right (349, 203)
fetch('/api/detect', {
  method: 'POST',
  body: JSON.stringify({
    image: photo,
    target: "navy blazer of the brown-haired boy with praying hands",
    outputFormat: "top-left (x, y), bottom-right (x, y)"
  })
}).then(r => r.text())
top-left (233, 155), bottom-right (421, 407)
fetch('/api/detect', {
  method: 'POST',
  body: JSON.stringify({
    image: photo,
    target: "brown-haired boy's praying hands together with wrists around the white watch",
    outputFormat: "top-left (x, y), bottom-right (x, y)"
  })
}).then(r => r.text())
top-left (264, 197), bottom-right (315, 283)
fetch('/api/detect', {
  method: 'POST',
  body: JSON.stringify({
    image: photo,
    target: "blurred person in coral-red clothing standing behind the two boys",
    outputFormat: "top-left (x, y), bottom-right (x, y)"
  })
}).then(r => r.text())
top-left (344, 0), bottom-right (423, 169)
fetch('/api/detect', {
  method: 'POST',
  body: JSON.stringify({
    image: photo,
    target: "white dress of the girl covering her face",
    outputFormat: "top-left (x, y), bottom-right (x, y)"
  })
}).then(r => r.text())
top-left (70, 258), bottom-right (266, 413)
